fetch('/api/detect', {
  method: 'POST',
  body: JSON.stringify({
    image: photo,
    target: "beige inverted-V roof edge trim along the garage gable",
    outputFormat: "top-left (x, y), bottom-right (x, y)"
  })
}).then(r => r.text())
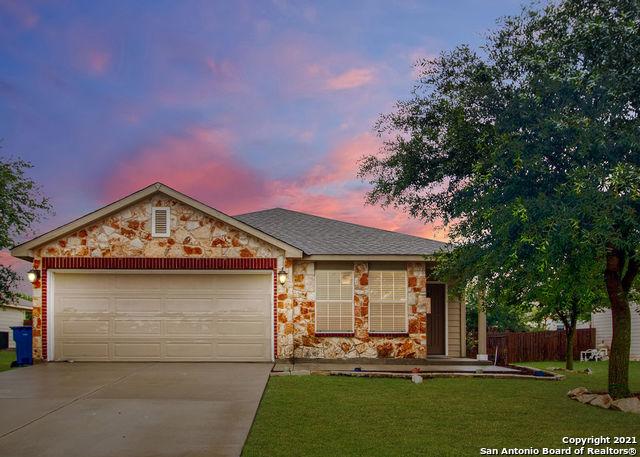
top-left (11, 183), bottom-right (302, 260)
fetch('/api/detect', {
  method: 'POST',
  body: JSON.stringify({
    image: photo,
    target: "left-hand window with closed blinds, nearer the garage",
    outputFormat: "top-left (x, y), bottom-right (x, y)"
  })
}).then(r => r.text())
top-left (316, 270), bottom-right (353, 333)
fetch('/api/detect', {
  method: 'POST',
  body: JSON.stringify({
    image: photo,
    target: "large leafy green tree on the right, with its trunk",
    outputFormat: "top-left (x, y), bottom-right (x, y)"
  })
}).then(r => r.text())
top-left (360, 0), bottom-right (640, 397)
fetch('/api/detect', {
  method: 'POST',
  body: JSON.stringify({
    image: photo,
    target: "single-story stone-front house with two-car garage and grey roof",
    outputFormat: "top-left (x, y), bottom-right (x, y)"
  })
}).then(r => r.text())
top-left (11, 183), bottom-right (486, 361)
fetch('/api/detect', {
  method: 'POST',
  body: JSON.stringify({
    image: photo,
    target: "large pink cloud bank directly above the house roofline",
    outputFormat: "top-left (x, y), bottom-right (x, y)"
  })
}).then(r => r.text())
top-left (104, 128), bottom-right (446, 239)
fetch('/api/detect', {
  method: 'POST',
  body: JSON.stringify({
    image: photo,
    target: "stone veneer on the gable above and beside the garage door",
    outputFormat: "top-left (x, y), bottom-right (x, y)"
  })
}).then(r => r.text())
top-left (33, 195), bottom-right (284, 359)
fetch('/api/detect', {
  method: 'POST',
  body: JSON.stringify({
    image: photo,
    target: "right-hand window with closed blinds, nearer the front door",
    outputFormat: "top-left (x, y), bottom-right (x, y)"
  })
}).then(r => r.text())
top-left (369, 271), bottom-right (407, 333)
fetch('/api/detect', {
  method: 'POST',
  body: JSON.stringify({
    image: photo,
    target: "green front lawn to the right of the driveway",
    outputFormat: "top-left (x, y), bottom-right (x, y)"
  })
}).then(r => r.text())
top-left (243, 362), bottom-right (640, 457)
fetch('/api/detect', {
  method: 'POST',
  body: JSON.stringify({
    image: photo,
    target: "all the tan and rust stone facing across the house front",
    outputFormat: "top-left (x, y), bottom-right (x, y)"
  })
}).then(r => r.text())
top-left (27, 194), bottom-right (427, 359)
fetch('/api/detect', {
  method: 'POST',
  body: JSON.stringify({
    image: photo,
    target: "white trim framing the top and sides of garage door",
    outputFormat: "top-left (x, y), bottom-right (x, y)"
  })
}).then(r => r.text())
top-left (47, 269), bottom-right (276, 362)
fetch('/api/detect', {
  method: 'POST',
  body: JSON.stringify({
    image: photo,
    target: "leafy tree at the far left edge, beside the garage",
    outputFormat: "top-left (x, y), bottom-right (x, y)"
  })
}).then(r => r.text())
top-left (0, 157), bottom-right (51, 303)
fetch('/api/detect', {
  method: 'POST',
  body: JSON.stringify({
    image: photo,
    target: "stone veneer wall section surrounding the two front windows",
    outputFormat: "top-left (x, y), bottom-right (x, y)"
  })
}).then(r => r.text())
top-left (286, 261), bottom-right (427, 359)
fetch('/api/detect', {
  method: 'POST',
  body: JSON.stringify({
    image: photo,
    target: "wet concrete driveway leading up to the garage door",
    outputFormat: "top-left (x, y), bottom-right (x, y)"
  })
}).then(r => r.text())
top-left (0, 363), bottom-right (272, 457)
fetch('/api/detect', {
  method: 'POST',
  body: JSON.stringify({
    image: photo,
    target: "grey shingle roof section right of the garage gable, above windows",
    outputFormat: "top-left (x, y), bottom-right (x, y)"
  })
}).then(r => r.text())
top-left (234, 208), bottom-right (446, 255)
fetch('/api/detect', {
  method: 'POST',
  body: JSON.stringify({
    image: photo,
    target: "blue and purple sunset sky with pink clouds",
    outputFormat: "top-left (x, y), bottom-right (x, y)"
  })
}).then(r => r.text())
top-left (0, 0), bottom-right (521, 278)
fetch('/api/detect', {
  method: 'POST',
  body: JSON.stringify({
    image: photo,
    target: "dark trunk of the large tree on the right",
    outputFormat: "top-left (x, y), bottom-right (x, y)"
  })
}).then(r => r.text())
top-left (605, 249), bottom-right (631, 398)
